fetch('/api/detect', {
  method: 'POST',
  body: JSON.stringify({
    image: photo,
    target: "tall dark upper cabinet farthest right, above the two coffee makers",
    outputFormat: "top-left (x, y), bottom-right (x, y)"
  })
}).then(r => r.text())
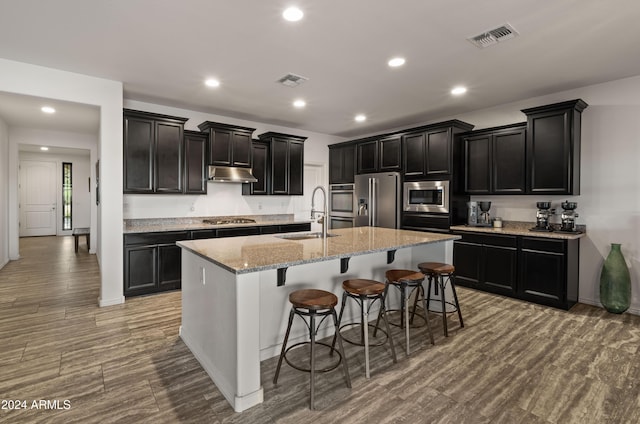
top-left (522, 99), bottom-right (587, 195)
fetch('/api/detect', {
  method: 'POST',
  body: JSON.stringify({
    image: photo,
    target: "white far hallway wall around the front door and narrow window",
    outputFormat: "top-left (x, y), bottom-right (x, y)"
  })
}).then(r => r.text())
top-left (18, 152), bottom-right (95, 235)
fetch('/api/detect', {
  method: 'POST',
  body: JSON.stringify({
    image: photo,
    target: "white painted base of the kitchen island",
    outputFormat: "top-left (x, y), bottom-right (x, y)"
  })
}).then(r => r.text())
top-left (179, 230), bottom-right (455, 412)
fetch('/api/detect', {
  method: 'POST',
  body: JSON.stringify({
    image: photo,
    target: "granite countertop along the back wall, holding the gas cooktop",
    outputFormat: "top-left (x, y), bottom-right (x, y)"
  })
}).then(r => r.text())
top-left (123, 214), bottom-right (311, 234)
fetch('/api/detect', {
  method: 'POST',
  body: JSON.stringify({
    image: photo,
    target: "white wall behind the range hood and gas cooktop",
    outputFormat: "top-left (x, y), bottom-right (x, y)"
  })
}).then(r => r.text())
top-left (124, 100), bottom-right (345, 219)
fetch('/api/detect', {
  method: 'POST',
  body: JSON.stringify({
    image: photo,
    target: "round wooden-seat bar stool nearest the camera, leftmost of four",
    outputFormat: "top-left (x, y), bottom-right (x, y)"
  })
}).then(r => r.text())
top-left (273, 289), bottom-right (351, 409)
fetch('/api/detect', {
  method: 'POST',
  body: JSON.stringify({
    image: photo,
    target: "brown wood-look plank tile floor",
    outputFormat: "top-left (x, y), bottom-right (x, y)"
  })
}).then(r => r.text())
top-left (0, 237), bottom-right (640, 423)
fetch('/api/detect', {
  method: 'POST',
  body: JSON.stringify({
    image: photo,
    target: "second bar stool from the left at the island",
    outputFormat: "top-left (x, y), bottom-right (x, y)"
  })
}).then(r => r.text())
top-left (332, 279), bottom-right (398, 378)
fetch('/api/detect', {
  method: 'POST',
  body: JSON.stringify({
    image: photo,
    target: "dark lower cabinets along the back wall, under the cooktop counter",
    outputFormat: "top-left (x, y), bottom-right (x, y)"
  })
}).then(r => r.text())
top-left (124, 223), bottom-right (311, 297)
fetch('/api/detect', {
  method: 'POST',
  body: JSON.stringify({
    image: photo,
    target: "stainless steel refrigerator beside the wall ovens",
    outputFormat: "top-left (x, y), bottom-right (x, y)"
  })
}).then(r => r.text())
top-left (354, 172), bottom-right (402, 228)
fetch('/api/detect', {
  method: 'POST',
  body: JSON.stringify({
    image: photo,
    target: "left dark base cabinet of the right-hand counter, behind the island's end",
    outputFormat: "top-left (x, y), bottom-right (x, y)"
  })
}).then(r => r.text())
top-left (453, 233), bottom-right (518, 296)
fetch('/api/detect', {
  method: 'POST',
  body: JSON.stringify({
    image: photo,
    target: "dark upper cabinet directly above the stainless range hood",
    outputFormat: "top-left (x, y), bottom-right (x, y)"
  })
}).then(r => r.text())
top-left (198, 121), bottom-right (255, 168)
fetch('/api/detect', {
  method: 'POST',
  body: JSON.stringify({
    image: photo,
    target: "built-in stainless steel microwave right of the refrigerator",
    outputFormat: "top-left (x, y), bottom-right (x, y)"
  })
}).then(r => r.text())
top-left (403, 181), bottom-right (449, 213)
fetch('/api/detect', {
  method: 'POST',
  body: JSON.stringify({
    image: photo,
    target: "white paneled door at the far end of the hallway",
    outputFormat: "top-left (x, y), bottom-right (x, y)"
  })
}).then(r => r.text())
top-left (20, 160), bottom-right (56, 237)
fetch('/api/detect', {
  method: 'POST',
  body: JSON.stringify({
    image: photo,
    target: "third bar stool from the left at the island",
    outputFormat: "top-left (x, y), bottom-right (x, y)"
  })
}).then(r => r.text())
top-left (374, 269), bottom-right (435, 356)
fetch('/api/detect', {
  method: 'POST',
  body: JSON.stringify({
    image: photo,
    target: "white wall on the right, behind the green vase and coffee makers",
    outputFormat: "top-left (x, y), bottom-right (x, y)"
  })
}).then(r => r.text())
top-left (436, 76), bottom-right (640, 314)
